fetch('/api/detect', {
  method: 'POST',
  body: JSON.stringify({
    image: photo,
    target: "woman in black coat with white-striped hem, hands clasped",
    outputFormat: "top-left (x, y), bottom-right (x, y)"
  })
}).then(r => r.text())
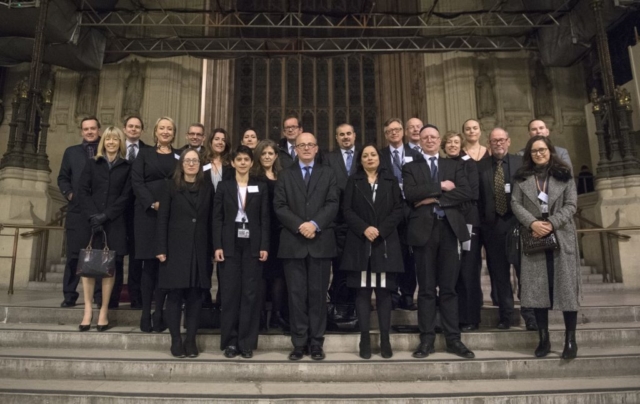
top-left (340, 144), bottom-right (404, 359)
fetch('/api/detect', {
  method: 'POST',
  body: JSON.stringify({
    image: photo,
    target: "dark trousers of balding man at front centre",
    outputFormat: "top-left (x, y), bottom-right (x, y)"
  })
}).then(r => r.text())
top-left (283, 256), bottom-right (331, 347)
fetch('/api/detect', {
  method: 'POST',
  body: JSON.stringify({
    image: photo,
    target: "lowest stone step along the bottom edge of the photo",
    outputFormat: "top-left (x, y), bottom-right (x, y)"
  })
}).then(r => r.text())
top-left (0, 377), bottom-right (640, 404)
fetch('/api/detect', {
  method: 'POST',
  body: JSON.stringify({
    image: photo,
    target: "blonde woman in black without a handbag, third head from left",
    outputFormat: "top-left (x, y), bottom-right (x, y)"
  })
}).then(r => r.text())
top-left (131, 117), bottom-right (179, 332)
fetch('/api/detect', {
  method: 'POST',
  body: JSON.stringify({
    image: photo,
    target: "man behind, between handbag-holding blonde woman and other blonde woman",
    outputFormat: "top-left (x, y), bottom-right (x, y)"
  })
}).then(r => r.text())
top-left (122, 116), bottom-right (149, 309)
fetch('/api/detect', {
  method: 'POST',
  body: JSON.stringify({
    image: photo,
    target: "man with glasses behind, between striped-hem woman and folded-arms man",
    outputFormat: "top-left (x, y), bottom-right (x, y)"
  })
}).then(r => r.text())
top-left (380, 118), bottom-right (422, 310)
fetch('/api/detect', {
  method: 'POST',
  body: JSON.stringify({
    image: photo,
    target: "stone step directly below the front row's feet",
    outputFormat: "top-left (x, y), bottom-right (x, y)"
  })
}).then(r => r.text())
top-left (0, 346), bottom-right (640, 388)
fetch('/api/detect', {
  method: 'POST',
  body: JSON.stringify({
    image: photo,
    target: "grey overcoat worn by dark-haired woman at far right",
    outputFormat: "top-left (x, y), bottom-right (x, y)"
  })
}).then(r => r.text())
top-left (511, 175), bottom-right (580, 311)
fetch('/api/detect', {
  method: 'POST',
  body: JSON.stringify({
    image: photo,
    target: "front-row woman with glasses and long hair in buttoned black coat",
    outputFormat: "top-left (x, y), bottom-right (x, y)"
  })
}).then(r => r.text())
top-left (157, 148), bottom-right (214, 358)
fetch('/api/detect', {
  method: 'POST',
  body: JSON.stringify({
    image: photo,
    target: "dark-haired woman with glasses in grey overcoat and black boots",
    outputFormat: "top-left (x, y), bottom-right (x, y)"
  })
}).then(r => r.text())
top-left (511, 136), bottom-right (580, 359)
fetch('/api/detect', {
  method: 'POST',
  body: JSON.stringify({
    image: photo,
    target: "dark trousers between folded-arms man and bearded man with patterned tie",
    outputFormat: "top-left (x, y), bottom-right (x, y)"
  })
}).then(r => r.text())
top-left (456, 227), bottom-right (482, 324)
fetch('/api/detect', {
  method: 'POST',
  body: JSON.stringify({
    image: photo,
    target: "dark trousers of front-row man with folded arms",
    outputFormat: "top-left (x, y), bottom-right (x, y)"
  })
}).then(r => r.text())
top-left (413, 218), bottom-right (460, 344)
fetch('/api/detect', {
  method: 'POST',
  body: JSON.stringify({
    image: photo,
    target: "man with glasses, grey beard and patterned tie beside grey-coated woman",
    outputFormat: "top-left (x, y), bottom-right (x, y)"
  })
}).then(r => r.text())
top-left (478, 128), bottom-right (537, 330)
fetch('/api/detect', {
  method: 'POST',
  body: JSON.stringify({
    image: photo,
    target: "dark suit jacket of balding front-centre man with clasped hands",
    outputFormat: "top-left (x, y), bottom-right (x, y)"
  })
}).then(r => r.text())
top-left (273, 163), bottom-right (340, 259)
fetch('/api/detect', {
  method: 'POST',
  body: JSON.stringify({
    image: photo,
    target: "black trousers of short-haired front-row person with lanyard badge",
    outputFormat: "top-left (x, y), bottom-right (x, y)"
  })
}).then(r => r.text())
top-left (218, 238), bottom-right (262, 350)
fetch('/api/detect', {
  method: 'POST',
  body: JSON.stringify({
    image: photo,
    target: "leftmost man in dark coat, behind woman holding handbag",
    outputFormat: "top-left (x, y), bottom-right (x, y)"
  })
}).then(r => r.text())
top-left (58, 116), bottom-right (101, 307)
